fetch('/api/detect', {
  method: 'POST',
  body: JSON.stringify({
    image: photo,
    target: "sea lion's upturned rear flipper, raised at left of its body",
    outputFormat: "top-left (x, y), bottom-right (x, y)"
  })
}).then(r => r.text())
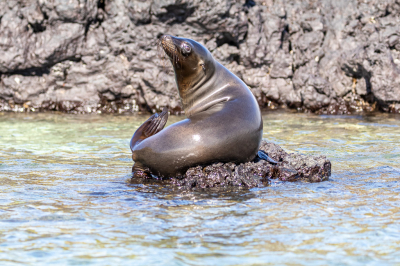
top-left (130, 107), bottom-right (168, 150)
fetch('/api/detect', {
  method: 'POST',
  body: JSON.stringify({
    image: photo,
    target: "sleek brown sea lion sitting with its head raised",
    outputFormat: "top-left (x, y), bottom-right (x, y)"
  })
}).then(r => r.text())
top-left (130, 35), bottom-right (263, 177)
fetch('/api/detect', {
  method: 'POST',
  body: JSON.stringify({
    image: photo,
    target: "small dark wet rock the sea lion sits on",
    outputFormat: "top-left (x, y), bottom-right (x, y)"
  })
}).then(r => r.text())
top-left (131, 141), bottom-right (331, 188)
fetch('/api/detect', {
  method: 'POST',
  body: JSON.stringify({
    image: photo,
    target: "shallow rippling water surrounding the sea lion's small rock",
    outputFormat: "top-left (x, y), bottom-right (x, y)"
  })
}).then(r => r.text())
top-left (0, 113), bottom-right (400, 265)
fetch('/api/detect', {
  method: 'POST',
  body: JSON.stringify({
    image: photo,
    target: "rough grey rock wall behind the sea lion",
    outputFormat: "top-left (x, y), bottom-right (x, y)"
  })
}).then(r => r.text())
top-left (0, 0), bottom-right (400, 114)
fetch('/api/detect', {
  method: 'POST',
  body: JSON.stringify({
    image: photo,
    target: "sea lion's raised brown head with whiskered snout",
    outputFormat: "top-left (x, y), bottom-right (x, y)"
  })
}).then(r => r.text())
top-left (161, 35), bottom-right (215, 97)
